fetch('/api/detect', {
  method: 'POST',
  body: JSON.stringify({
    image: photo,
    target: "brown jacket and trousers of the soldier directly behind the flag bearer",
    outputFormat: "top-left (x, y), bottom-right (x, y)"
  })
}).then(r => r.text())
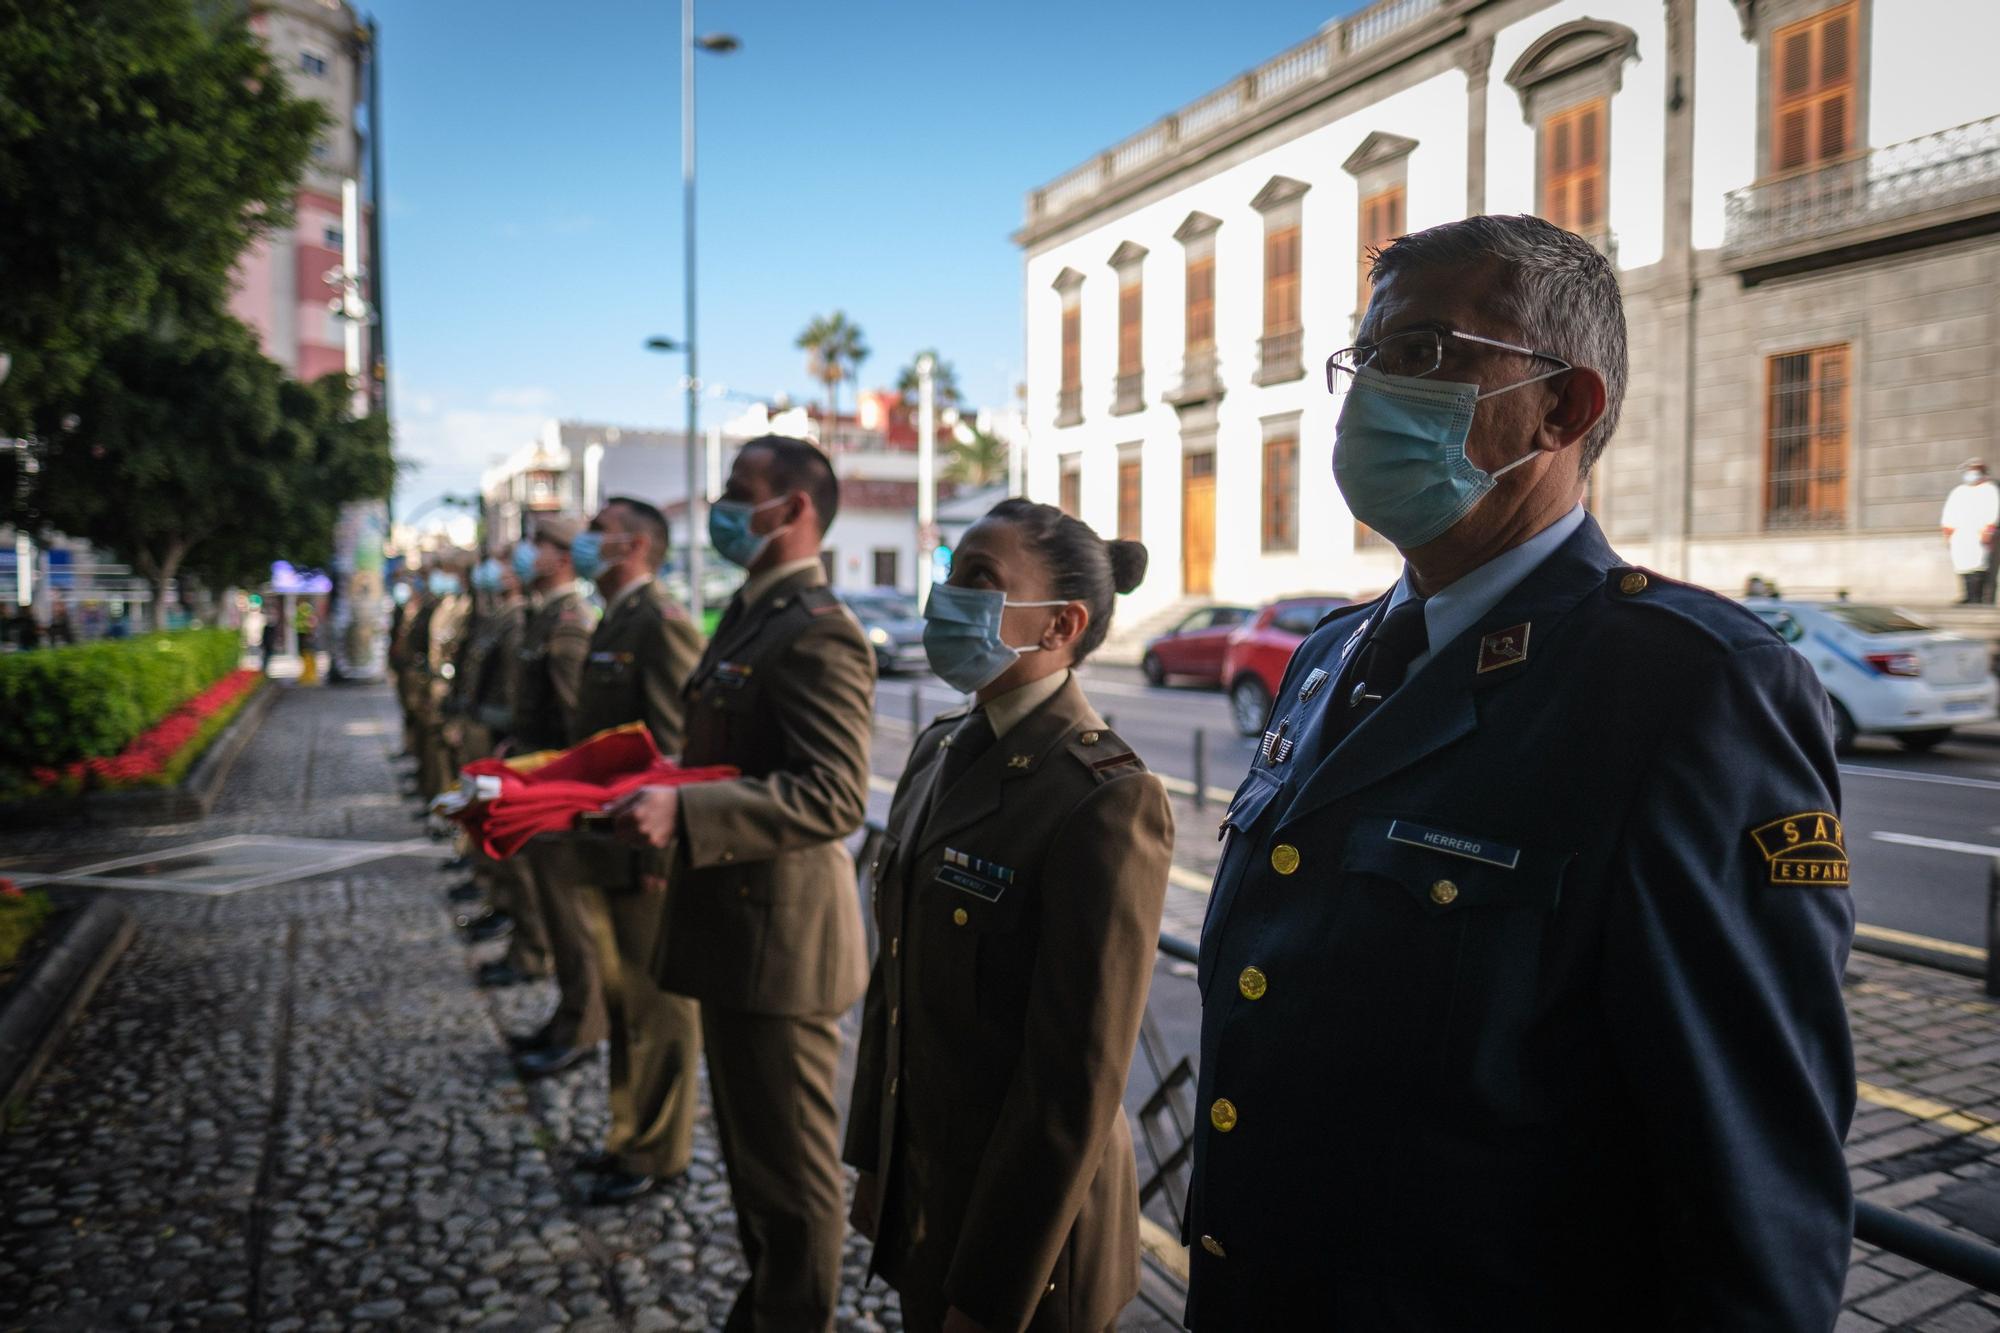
top-left (564, 580), bottom-right (702, 1175)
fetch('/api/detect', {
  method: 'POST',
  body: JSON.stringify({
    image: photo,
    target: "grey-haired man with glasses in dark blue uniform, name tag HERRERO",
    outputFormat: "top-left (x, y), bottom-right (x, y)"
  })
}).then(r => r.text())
top-left (1186, 218), bottom-right (1854, 1333)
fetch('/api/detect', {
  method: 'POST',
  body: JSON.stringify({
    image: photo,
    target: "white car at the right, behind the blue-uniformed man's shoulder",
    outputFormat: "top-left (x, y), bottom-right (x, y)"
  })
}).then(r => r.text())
top-left (1744, 596), bottom-right (2000, 751)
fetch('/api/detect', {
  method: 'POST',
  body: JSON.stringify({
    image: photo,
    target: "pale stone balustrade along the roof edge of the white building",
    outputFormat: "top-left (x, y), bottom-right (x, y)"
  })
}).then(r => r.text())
top-left (1026, 0), bottom-right (1464, 228)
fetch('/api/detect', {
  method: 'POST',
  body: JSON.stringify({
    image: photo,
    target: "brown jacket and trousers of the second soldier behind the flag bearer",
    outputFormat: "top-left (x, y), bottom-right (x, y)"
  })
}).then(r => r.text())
top-left (508, 582), bottom-right (610, 1051)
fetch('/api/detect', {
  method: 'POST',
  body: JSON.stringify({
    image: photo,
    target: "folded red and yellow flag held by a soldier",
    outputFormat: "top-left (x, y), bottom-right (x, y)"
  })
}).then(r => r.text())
top-left (434, 723), bottom-right (738, 861)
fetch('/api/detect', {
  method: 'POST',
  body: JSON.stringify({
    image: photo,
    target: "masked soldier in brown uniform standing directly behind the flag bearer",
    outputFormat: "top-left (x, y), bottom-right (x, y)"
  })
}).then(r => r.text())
top-left (532, 498), bottom-right (702, 1203)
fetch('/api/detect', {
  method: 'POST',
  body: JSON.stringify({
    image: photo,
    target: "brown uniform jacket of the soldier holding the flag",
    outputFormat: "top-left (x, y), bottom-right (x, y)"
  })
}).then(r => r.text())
top-left (654, 568), bottom-right (874, 1017)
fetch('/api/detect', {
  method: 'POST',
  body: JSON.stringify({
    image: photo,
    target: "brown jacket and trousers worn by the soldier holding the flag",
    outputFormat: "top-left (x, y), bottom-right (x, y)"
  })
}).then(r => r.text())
top-left (656, 566), bottom-right (874, 1333)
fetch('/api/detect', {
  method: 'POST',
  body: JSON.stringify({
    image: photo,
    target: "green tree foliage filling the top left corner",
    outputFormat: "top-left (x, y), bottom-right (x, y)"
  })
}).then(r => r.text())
top-left (0, 0), bottom-right (326, 436)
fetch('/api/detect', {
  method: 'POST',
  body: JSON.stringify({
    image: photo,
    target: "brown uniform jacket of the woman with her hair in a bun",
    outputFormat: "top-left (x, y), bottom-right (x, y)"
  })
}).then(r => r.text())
top-left (844, 679), bottom-right (1174, 1333)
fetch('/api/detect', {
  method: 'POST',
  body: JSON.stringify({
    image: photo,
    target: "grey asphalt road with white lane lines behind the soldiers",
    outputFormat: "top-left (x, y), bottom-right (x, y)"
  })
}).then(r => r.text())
top-left (876, 667), bottom-right (2000, 947)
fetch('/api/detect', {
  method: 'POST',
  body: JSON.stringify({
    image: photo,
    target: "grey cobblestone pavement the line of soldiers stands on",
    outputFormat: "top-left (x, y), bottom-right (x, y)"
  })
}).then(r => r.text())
top-left (0, 689), bottom-right (2000, 1333)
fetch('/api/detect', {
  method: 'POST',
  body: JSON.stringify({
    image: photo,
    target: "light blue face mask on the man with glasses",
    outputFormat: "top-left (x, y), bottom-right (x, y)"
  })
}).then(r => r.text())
top-left (1334, 366), bottom-right (1560, 550)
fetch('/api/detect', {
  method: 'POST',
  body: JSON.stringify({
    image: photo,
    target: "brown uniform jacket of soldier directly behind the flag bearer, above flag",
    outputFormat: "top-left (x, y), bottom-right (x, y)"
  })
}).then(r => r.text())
top-left (570, 580), bottom-right (702, 755)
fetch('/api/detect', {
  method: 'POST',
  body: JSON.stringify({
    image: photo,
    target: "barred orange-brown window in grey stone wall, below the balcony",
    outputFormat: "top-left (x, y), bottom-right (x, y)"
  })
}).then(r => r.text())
top-left (1764, 344), bottom-right (1848, 528)
